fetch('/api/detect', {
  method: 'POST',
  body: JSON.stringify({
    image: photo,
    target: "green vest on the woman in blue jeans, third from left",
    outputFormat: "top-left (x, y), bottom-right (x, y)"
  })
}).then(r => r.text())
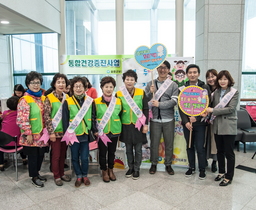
top-left (66, 96), bottom-right (92, 136)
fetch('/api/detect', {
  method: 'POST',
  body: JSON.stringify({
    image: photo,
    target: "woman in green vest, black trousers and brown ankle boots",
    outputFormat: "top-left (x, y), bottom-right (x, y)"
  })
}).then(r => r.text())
top-left (94, 77), bottom-right (122, 182)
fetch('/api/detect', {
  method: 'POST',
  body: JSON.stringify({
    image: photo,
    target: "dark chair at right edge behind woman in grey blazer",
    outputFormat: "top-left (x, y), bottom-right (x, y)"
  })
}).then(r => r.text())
top-left (236, 110), bottom-right (256, 153)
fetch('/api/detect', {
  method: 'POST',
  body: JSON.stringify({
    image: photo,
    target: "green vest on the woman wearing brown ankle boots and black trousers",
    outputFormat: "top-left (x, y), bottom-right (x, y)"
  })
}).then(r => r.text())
top-left (94, 97), bottom-right (122, 134)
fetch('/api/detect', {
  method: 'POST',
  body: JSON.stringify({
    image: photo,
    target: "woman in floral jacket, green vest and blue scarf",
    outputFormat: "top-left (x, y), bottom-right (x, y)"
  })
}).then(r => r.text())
top-left (17, 71), bottom-right (49, 187)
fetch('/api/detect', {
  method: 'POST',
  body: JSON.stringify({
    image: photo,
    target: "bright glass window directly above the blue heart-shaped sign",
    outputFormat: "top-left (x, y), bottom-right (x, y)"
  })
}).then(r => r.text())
top-left (124, 0), bottom-right (175, 55)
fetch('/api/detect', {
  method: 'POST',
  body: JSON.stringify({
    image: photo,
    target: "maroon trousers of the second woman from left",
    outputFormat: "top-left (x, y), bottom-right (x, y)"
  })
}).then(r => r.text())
top-left (50, 138), bottom-right (67, 179)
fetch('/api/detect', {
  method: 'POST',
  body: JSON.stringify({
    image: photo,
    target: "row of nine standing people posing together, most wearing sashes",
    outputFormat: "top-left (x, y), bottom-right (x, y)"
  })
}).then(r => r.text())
top-left (0, 61), bottom-right (238, 187)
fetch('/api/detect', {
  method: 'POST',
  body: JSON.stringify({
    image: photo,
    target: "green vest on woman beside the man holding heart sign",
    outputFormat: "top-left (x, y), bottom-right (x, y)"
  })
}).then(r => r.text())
top-left (116, 88), bottom-right (144, 125)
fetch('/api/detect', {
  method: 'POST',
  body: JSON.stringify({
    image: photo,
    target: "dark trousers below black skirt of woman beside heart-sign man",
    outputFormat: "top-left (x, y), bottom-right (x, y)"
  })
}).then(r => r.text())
top-left (125, 142), bottom-right (142, 171)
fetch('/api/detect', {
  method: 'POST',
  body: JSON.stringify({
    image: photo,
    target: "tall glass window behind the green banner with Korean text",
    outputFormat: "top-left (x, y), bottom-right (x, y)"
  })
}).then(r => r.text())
top-left (66, 0), bottom-right (116, 93)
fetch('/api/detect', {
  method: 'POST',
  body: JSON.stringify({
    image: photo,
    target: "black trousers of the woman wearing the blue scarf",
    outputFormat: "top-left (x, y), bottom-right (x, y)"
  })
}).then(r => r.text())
top-left (28, 151), bottom-right (44, 177)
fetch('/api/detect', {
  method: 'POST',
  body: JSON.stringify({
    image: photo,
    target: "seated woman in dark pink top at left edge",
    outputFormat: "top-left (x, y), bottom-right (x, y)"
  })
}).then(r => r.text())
top-left (0, 96), bottom-right (27, 171)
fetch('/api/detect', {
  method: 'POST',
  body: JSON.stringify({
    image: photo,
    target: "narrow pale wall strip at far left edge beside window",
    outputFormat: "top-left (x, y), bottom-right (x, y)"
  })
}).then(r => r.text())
top-left (0, 35), bottom-right (13, 99)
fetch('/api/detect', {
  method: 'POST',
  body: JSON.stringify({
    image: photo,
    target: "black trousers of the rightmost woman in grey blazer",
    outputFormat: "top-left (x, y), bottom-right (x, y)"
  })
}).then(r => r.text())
top-left (214, 134), bottom-right (236, 180)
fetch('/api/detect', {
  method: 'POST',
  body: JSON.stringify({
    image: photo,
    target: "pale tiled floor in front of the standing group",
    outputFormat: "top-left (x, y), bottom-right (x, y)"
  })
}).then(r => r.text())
top-left (0, 144), bottom-right (256, 210)
